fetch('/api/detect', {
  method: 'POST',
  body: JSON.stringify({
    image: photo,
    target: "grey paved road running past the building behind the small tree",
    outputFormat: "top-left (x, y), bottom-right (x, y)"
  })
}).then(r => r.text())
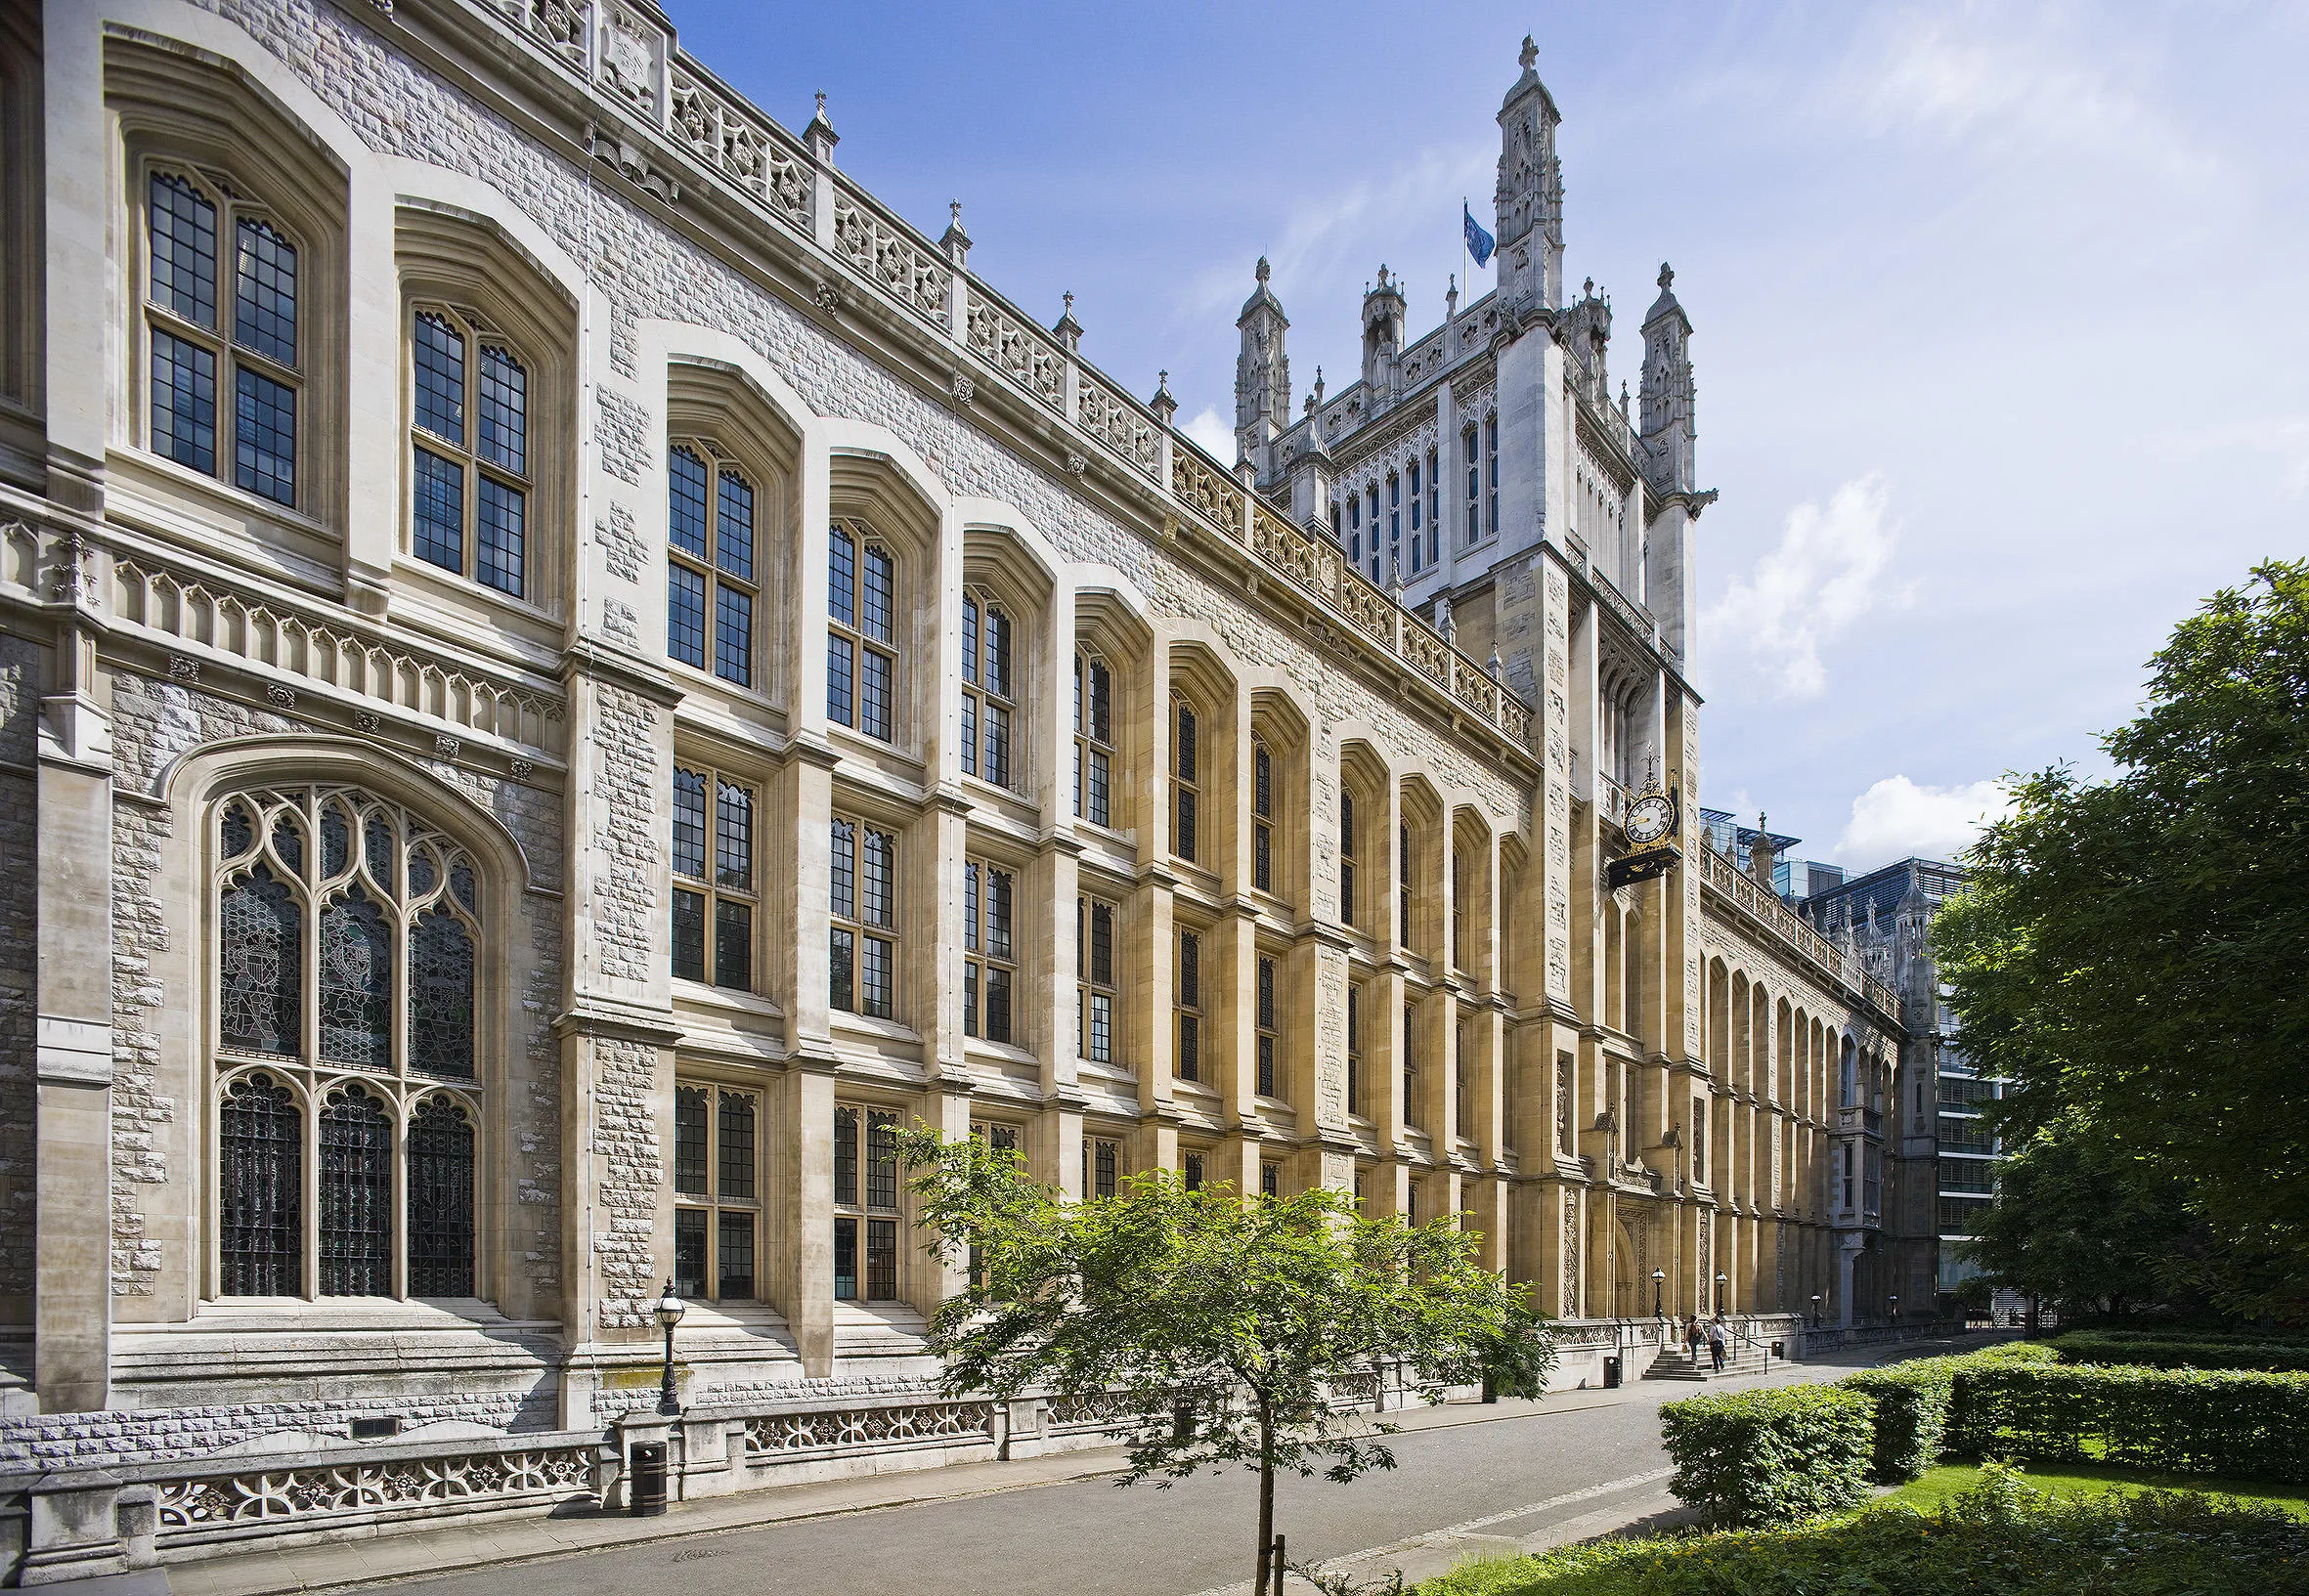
top-left (393, 1381), bottom-right (1748, 1596)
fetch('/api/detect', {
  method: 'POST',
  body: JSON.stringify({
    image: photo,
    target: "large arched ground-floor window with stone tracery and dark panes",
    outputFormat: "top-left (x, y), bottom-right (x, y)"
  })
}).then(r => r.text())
top-left (210, 786), bottom-right (483, 1296)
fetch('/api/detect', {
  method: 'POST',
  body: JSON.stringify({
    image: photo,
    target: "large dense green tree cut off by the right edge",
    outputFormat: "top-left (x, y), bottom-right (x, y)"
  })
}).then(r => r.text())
top-left (1933, 561), bottom-right (2309, 1321)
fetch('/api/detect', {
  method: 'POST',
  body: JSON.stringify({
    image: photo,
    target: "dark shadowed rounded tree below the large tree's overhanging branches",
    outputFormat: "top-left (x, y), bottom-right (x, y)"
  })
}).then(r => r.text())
top-left (1965, 1113), bottom-right (2194, 1315)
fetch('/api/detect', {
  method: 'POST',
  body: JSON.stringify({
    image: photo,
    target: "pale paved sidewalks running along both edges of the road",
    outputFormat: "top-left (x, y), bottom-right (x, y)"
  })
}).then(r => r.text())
top-left (144, 1342), bottom-right (1946, 1596)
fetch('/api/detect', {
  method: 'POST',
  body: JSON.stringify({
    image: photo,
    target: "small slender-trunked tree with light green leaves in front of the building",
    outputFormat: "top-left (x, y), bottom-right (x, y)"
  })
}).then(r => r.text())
top-left (903, 1130), bottom-right (1554, 1596)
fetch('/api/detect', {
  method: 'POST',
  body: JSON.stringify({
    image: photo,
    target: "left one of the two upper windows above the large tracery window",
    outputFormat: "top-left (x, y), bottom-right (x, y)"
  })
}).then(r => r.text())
top-left (146, 171), bottom-right (305, 506)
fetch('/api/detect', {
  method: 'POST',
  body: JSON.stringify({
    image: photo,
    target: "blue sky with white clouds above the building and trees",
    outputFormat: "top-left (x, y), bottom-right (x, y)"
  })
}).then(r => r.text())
top-left (672, 0), bottom-right (2309, 871)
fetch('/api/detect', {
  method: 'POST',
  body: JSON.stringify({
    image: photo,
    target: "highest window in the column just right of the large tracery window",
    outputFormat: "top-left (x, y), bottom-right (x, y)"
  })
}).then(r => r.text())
top-left (665, 439), bottom-right (760, 688)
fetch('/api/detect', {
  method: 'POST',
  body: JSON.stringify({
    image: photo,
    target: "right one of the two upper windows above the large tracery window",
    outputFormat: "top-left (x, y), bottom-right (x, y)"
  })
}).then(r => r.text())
top-left (409, 305), bottom-right (534, 598)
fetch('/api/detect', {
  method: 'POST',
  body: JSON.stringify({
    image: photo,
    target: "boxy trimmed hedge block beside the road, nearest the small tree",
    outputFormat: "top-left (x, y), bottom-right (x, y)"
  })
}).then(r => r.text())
top-left (1660, 1386), bottom-right (1875, 1529)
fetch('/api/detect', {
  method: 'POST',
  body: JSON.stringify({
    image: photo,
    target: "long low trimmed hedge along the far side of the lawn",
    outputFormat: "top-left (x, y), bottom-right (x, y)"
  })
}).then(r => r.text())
top-left (1946, 1362), bottom-right (2309, 1486)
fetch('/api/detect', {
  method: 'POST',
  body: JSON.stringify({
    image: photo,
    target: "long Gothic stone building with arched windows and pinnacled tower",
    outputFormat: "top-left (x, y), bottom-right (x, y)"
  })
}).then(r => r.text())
top-left (0, 0), bottom-right (1898, 1460)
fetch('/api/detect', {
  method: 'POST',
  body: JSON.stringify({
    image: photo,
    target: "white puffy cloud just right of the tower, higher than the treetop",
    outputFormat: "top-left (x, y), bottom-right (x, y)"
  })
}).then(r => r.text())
top-left (1702, 473), bottom-right (1907, 698)
